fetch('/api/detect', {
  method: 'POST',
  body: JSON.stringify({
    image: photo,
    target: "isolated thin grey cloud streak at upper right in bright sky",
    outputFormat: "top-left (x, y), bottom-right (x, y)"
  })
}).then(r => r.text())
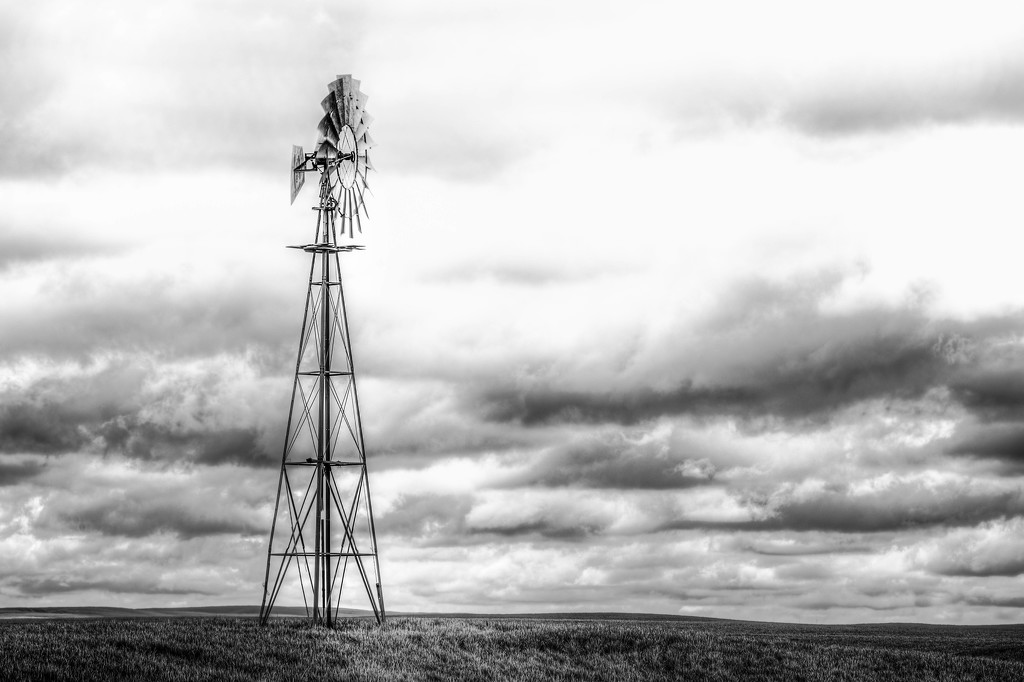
top-left (657, 45), bottom-right (1024, 140)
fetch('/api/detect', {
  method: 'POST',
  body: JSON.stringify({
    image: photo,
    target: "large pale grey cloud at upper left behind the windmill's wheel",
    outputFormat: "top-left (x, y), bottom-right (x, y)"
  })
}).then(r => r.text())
top-left (0, 1), bottom-right (542, 182)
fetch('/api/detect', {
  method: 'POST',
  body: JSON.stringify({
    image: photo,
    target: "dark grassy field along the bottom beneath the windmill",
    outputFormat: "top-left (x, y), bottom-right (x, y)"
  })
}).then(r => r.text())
top-left (0, 617), bottom-right (1024, 680)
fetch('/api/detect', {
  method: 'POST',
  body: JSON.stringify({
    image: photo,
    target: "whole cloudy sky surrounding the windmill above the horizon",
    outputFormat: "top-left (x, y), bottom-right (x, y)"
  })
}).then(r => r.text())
top-left (0, 0), bottom-right (1024, 624)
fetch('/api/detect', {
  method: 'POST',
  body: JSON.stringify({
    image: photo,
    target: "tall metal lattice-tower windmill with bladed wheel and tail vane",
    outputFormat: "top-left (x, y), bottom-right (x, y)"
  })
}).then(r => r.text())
top-left (260, 75), bottom-right (384, 625)
